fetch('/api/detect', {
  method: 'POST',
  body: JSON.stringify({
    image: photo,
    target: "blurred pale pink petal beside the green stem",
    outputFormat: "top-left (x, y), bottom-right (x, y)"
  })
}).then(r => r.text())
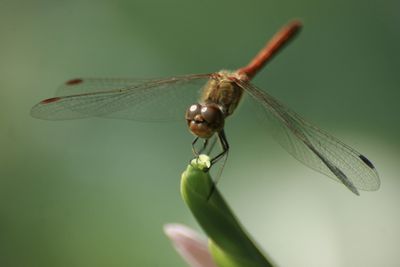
top-left (164, 224), bottom-right (217, 267)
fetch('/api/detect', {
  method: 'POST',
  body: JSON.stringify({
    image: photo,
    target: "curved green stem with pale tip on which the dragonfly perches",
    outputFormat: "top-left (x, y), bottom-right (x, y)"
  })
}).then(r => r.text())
top-left (181, 155), bottom-right (273, 267)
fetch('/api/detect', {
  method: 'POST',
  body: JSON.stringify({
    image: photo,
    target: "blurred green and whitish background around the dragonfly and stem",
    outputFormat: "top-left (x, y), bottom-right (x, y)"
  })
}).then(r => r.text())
top-left (0, 0), bottom-right (400, 267)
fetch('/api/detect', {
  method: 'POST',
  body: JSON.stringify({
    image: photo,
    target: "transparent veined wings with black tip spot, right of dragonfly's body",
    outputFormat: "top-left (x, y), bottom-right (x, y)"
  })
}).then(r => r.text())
top-left (237, 81), bottom-right (380, 195)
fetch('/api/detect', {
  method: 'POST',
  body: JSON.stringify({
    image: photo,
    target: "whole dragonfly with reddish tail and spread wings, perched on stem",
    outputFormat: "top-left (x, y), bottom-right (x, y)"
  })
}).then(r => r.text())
top-left (31, 20), bottom-right (380, 195)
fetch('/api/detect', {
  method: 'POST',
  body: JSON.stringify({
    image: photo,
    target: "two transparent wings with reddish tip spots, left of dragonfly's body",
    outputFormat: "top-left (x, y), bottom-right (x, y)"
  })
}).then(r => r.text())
top-left (31, 74), bottom-right (211, 121)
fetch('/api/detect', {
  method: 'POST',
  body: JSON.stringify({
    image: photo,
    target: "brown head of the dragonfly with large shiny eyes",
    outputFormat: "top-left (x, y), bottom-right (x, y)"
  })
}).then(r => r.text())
top-left (185, 104), bottom-right (225, 138)
